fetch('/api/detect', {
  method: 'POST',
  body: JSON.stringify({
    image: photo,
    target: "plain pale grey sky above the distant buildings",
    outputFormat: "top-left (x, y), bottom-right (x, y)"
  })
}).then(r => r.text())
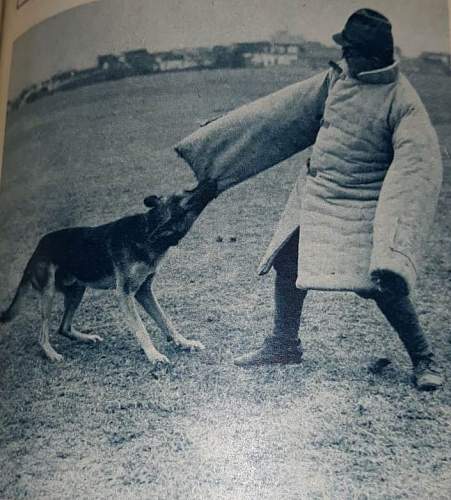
top-left (10, 0), bottom-right (449, 98)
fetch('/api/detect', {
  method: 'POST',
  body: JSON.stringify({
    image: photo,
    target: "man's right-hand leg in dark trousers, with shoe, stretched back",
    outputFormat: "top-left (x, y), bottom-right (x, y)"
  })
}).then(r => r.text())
top-left (375, 280), bottom-right (443, 390)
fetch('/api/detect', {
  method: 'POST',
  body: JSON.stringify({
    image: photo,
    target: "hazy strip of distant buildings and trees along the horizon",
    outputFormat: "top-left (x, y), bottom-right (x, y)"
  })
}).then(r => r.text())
top-left (15, 31), bottom-right (428, 113)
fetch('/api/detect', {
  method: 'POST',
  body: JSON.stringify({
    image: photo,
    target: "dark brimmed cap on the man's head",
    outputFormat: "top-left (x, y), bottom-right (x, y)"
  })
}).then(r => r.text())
top-left (332, 9), bottom-right (393, 55)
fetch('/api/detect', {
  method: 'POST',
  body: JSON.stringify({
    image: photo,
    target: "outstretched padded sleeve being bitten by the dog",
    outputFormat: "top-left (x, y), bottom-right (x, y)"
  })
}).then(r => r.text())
top-left (175, 70), bottom-right (332, 192)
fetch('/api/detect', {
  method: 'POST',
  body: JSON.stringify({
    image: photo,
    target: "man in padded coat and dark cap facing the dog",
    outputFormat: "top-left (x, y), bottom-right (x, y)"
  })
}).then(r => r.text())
top-left (176, 9), bottom-right (443, 390)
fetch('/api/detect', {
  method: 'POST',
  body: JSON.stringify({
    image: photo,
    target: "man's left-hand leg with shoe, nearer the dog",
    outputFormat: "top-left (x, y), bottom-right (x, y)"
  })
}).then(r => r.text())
top-left (235, 231), bottom-right (307, 367)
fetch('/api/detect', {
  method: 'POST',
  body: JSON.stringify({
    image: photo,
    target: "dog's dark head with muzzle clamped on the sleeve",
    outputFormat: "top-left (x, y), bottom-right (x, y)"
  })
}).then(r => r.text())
top-left (144, 180), bottom-right (217, 246)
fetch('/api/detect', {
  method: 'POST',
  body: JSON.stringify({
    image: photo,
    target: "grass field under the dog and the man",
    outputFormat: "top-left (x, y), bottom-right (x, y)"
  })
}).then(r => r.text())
top-left (0, 67), bottom-right (451, 500)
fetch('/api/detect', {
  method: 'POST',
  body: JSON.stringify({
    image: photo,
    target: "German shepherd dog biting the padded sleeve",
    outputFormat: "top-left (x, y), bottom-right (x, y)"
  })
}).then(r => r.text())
top-left (0, 180), bottom-right (217, 365)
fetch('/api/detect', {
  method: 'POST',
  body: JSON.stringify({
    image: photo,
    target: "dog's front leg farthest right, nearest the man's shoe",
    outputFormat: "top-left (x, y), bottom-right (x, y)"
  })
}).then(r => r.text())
top-left (136, 275), bottom-right (204, 350)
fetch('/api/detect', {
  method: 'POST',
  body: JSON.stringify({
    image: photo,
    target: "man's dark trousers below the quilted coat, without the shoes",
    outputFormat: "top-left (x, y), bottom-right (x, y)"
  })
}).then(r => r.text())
top-left (273, 230), bottom-right (432, 365)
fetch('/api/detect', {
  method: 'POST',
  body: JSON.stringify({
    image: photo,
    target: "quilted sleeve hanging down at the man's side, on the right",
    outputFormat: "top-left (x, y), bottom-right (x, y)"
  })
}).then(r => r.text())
top-left (370, 82), bottom-right (443, 292)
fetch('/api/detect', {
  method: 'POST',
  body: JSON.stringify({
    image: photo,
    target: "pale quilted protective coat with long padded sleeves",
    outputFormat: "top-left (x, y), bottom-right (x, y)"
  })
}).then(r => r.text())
top-left (176, 61), bottom-right (442, 293)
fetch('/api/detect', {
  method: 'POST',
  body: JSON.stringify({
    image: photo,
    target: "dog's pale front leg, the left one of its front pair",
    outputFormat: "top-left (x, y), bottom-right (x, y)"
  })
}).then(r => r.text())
top-left (116, 276), bottom-right (169, 364)
